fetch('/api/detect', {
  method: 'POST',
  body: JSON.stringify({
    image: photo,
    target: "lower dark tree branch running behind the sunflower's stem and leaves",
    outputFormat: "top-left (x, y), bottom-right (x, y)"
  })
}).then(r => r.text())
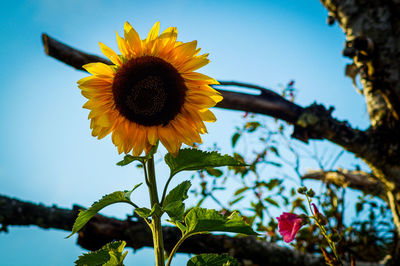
top-left (0, 196), bottom-right (323, 266)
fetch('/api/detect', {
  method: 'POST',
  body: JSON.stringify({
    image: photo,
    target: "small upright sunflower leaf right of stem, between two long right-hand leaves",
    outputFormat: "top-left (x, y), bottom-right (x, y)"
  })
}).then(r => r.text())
top-left (163, 181), bottom-right (192, 220)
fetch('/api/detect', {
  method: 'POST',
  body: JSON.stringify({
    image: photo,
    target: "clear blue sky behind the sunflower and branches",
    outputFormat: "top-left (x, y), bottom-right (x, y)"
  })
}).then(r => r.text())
top-left (0, 0), bottom-right (368, 266)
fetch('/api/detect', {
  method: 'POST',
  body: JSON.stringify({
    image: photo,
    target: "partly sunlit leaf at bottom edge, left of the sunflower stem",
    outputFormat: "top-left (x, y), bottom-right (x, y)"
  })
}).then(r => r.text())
top-left (75, 241), bottom-right (128, 266)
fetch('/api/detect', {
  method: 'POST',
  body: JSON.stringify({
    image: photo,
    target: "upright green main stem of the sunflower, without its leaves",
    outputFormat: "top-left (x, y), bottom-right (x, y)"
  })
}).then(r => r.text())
top-left (147, 156), bottom-right (165, 266)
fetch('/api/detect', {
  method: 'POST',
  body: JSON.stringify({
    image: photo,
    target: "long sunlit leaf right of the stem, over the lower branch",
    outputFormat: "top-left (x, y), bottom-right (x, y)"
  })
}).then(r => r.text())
top-left (185, 207), bottom-right (257, 235)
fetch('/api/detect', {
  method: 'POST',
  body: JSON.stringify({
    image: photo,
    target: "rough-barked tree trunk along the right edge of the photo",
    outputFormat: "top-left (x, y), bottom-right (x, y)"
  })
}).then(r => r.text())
top-left (321, 0), bottom-right (400, 254)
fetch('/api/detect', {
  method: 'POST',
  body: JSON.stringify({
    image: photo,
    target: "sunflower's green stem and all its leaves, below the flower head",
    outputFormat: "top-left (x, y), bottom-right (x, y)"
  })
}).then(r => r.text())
top-left (70, 145), bottom-right (252, 266)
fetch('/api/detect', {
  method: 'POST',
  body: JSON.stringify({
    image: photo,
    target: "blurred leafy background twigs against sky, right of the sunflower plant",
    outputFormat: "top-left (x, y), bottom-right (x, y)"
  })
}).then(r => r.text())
top-left (192, 81), bottom-right (394, 261)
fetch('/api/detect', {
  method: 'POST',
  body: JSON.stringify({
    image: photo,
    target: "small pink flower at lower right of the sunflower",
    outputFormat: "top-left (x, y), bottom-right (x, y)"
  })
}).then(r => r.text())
top-left (276, 212), bottom-right (303, 243)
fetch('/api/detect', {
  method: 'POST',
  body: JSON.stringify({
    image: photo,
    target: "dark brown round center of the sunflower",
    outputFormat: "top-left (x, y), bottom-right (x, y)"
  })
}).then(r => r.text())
top-left (112, 56), bottom-right (187, 126)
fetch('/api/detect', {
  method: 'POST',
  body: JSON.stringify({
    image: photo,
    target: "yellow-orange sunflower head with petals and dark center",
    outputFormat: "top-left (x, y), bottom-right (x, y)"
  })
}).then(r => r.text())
top-left (78, 22), bottom-right (222, 156)
